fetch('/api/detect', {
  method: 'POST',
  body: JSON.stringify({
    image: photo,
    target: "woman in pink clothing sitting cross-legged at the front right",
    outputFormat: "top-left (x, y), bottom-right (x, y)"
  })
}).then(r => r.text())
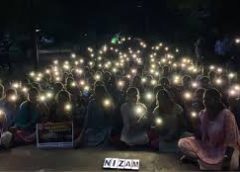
top-left (178, 89), bottom-right (239, 170)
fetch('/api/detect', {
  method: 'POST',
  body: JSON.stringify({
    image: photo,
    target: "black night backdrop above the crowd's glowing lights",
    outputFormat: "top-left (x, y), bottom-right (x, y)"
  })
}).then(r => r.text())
top-left (0, 0), bottom-right (240, 49)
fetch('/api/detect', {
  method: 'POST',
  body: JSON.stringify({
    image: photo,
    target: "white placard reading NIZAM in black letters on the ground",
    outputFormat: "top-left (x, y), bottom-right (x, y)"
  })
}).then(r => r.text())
top-left (103, 158), bottom-right (140, 170)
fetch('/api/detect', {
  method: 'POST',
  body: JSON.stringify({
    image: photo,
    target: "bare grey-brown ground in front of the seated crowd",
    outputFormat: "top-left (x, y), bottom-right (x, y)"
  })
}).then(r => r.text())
top-left (0, 145), bottom-right (198, 171)
